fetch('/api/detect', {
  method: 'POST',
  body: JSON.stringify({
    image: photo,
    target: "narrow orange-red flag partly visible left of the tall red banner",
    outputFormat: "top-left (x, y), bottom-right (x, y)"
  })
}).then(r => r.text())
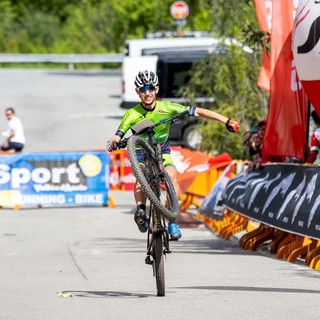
top-left (254, 0), bottom-right (272, 91)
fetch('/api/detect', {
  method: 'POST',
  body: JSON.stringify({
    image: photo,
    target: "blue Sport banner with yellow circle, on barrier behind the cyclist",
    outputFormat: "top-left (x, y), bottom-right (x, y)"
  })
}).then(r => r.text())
top-left (0, 152), bottom-right (110, 206)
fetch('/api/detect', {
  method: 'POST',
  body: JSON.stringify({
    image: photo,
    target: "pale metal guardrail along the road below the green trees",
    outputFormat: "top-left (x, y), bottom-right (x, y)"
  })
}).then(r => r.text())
top-left (0, 53), bottom-right (124, 69)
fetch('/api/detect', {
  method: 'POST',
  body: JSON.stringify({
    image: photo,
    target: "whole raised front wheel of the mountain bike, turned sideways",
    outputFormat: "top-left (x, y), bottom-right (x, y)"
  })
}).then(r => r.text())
top-left (127, 136), bottom-right (179, 220)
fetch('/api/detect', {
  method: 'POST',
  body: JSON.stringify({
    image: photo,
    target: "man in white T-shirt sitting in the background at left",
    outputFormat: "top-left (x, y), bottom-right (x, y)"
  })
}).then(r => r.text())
top-left (1, 107), bottom-right (25, 152)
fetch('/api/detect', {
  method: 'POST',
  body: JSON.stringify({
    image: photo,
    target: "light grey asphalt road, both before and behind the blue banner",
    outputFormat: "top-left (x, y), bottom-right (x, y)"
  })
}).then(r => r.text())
top-left (0, 70), bottom-right (320, 320)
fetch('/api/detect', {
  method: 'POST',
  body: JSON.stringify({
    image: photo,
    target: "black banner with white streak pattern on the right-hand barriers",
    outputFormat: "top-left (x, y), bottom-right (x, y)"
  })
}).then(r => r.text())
top-left (222, 164), bottom-right (320, 239)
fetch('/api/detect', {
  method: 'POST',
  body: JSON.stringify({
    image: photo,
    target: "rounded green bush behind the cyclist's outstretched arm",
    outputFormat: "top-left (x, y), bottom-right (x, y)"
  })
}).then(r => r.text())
top-left (183, 45), bottom-right (266, 159)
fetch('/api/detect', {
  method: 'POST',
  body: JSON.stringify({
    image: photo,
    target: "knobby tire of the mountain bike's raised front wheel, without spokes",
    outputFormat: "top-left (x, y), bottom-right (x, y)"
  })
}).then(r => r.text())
top-left (127, 136), bottom-right (179, 221)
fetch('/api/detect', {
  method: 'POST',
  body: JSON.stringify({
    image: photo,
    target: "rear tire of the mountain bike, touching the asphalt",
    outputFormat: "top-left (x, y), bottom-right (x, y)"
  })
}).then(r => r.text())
top-left (153, 233), bottom-right (165, 296)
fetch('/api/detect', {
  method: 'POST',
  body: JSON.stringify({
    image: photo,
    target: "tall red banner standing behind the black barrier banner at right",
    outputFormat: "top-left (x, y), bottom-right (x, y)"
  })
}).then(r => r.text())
top-left (262, 0), bottom-right (308, 162)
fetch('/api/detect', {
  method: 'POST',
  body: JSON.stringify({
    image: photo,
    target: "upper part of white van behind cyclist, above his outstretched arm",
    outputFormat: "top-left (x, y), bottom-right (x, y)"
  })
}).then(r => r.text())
top-left (120, 32), bottom-right (219, 108)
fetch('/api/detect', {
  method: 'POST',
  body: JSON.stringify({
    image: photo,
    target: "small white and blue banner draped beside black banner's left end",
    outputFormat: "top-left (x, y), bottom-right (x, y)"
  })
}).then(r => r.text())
top-left (199, 162), bottom-right (234, 220)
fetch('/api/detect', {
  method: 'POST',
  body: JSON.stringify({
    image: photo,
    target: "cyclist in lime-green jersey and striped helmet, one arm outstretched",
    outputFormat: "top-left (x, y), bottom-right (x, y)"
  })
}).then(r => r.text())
top-left (107, 70), bottom-right (239, 240)
